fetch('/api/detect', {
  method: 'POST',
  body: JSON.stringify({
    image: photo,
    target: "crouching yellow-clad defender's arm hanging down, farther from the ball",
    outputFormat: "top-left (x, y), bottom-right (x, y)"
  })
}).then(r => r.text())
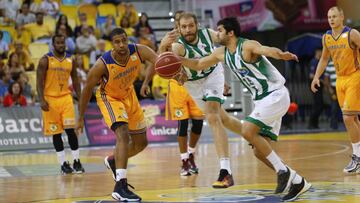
top-left (75, 59), bottom-right (107, 135)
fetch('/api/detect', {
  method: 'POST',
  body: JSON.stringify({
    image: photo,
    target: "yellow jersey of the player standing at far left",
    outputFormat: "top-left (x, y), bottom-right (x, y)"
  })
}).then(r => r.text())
top-left (44, 52), bottom-right (73, 97)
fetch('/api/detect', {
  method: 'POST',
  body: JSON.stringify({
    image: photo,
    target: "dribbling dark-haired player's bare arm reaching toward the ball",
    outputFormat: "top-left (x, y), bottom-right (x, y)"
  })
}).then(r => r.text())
top-left (180, 47), bottom-right (225, 70)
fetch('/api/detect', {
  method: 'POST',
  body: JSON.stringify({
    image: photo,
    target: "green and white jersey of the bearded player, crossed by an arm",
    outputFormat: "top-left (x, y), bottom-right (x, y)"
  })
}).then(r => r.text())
top-left (178, 28), bottom-right (221, 81)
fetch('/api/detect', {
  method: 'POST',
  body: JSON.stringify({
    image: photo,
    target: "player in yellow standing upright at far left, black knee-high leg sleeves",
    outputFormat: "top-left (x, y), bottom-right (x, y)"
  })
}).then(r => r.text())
top-left (36, 35), bottom-right (85, 174)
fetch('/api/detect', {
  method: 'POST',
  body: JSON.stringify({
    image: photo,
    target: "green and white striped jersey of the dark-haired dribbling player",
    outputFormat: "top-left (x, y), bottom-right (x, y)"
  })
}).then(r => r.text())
top-left (225, 38), bottom-right (285, 100)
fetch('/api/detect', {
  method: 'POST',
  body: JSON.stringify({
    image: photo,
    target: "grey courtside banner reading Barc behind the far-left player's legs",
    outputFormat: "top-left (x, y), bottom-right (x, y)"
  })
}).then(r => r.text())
top-left (0, 106), bottom-right (89, 151)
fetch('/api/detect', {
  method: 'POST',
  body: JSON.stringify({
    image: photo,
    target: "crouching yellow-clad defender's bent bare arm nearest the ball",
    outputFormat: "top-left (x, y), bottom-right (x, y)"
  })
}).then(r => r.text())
top-left (136, 44), bottom-right (158, 97)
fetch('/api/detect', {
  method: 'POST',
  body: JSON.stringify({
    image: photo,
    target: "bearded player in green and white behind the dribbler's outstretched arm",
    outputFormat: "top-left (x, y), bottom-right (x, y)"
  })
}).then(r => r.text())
top-left (150, 13), bottom-right (234, 188)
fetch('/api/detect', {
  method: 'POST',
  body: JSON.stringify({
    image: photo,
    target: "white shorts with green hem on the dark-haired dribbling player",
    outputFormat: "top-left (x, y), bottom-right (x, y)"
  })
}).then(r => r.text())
top-left (245, 86), bottom-right (290, 141)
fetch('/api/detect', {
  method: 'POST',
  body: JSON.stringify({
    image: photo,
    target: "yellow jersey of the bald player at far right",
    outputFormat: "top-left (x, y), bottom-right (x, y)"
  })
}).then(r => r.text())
top-left (324, 26), bottom-right (359, 76)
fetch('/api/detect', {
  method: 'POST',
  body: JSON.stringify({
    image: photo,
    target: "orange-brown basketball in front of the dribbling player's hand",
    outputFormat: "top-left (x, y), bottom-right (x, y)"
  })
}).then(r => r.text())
top-left (155, 52), bottom-right (181, 79)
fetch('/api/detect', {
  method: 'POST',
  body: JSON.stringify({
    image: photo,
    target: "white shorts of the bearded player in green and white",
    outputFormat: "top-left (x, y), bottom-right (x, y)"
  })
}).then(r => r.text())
top-left (184, 64), bottom-right (225, 112)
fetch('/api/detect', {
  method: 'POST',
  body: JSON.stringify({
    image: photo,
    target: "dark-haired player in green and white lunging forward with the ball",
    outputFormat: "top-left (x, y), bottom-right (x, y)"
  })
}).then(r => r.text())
top-left (173, 17), bottom-right (311, 201)
